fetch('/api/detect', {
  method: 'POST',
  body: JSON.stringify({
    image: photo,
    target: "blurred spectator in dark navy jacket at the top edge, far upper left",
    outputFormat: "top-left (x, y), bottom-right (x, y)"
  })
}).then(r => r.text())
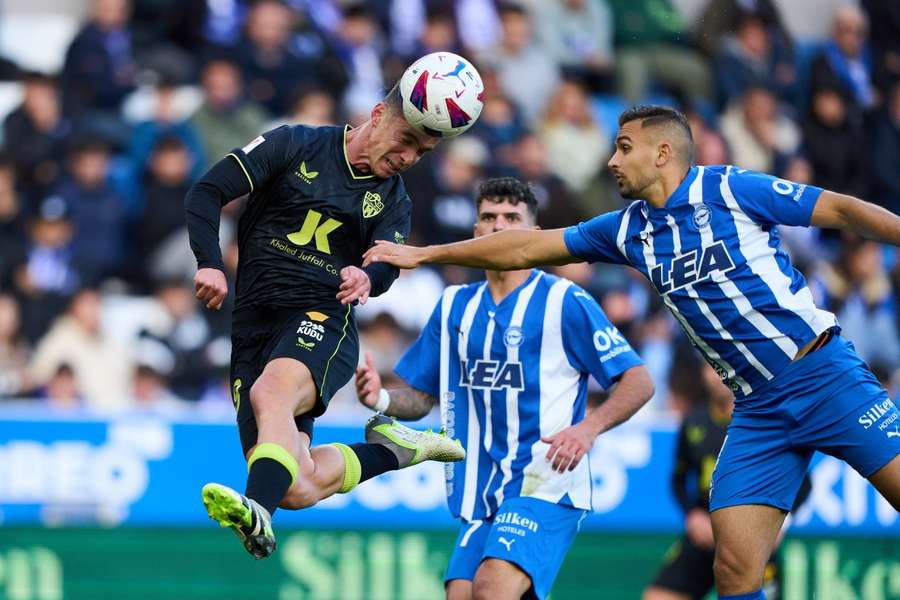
top-left (62, 0), bottom-right (137, 117)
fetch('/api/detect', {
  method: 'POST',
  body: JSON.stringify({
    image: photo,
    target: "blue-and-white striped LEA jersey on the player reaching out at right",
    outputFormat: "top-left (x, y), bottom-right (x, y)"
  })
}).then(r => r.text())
top-left (565, 166), bottom-right (836, 401)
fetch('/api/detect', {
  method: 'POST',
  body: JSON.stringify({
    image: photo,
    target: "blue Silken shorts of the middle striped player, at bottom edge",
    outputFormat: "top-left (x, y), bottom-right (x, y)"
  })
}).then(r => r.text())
top-left (445, 498), bottom-right (587, 599)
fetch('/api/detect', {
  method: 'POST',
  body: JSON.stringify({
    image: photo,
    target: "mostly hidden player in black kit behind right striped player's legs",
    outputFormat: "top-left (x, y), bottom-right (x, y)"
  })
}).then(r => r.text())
top-left (643, 363), bottom-right (811, 600)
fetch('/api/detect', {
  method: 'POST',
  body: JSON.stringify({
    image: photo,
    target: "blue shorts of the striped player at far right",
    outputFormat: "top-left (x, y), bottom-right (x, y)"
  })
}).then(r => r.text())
top-left (709, 335), bottom-right (900, 511)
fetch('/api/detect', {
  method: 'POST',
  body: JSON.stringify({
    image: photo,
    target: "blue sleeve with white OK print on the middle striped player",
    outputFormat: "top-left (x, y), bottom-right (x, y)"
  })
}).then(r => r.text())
top-left (562, 285), bottom-right (644, 388)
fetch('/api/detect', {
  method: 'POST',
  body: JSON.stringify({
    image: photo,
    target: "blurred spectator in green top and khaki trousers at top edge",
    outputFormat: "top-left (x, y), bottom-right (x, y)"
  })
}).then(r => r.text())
top-left (608, 0), bottom-right (713, 103)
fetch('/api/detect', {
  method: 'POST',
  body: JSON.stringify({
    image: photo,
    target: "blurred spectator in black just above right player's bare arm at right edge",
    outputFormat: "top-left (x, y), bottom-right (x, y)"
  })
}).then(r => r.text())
top-left (803, 85), bottom-right (868, 197)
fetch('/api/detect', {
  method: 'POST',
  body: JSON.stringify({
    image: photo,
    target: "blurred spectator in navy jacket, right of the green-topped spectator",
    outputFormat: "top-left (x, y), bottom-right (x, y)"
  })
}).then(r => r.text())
top-left (715, 13), bottom-right (796, 106)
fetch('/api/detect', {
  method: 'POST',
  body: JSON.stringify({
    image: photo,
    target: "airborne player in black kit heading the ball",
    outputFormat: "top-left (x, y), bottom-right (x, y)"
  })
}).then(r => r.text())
top-left (185, 86), bottom-right (464, 558)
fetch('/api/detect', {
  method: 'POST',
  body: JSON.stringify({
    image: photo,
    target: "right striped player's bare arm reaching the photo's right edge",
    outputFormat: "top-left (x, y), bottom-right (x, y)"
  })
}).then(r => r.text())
top-left (810, 190), bottom-right (900, 241)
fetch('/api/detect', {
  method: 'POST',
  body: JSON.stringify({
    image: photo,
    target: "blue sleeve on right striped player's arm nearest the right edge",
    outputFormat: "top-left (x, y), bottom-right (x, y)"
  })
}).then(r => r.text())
top-left (725, 168), bottom-right (822, 227)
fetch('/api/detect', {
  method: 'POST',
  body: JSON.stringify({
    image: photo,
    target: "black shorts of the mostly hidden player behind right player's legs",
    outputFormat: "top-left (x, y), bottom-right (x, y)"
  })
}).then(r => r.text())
top-left (650, 535), bottom-right (781, 600)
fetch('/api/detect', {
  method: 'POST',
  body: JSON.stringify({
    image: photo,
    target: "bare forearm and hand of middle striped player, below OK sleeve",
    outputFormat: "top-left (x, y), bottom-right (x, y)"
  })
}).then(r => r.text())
top-left (541, 365), bottom-right (653, 473)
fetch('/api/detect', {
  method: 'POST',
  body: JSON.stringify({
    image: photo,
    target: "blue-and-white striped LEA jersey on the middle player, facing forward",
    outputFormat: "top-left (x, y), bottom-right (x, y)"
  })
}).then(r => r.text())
top-left (396, 269), bottom-right (642, 521)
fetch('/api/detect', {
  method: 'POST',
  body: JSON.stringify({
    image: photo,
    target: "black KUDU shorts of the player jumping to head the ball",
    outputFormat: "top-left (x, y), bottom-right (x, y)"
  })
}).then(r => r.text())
top-left (231, 305), bottom-right (359, 455)
